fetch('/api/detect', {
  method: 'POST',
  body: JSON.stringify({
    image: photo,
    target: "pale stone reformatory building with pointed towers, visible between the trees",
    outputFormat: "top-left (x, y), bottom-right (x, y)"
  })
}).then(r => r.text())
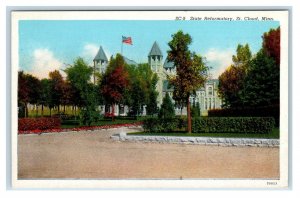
top-left (93, 41), bottom-right (222, 115)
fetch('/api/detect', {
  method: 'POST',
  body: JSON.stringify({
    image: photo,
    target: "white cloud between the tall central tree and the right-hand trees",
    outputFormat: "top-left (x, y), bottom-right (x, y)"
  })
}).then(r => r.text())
top-left (204, 48), bottom-right (235, 78)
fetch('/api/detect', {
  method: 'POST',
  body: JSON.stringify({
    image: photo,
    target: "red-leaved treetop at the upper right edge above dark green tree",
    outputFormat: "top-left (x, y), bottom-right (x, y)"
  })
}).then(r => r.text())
top-left (263, 27), bottom-right (280, 67)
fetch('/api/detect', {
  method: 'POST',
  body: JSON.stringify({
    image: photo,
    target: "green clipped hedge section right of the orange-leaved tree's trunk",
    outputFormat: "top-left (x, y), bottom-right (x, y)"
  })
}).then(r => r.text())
top-left (192, 117), bottom-right (275, 134)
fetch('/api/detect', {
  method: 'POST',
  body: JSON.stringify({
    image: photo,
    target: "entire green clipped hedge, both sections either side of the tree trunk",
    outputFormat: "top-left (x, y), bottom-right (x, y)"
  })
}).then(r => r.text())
top-left (143, 117), bottom-right (275, 134)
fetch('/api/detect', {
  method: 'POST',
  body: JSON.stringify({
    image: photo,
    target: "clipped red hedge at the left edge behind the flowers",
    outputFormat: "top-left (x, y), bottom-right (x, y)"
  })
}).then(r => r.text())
top-left (18, 118), bottom-right (61, 131)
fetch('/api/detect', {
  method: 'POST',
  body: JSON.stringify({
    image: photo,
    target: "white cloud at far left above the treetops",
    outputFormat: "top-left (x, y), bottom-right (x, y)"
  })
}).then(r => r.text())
top-left (30, 48), bottom-right (64, 79)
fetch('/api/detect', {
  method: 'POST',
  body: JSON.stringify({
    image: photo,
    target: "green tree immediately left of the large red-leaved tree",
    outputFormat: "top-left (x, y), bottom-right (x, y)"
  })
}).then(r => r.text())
top-left (65, 58), bottom-right (99, 126)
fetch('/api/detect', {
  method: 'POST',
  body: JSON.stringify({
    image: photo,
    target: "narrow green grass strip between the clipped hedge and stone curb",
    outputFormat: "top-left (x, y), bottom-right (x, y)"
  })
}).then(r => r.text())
top-left (128, 128), bottom-right (279, 139)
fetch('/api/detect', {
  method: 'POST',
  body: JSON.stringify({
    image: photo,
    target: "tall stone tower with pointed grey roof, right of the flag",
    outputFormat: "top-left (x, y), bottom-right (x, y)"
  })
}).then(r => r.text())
top-left (148, 41), bottom-right (165, 105)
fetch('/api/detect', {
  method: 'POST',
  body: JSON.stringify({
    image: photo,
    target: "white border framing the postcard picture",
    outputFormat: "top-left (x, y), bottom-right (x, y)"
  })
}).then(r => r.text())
top-left (11, 11), bottom-right (289, 189)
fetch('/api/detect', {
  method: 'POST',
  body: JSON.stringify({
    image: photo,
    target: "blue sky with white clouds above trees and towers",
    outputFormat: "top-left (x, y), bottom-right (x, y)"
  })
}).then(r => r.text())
top-left (19, 20), bottom-right (279, 78)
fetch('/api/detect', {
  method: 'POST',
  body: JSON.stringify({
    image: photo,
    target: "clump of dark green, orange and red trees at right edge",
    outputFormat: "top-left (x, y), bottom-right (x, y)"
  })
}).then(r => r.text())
top-left (219, 28), bottom-right (280, 110)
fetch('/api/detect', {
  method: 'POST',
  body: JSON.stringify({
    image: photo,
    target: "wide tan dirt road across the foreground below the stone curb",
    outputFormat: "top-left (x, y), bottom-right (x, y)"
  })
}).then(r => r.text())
top-left (18, 129), bottom-right (279, 179)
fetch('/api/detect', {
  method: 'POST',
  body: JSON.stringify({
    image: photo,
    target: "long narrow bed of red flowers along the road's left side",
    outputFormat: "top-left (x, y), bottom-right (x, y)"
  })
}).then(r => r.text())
top-left (18, 122), bottom-right (142, 134)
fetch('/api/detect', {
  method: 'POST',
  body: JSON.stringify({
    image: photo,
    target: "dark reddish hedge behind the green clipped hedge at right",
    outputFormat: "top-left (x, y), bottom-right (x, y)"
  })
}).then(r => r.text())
top-left (208, 105), bottom-right (280, 126)
